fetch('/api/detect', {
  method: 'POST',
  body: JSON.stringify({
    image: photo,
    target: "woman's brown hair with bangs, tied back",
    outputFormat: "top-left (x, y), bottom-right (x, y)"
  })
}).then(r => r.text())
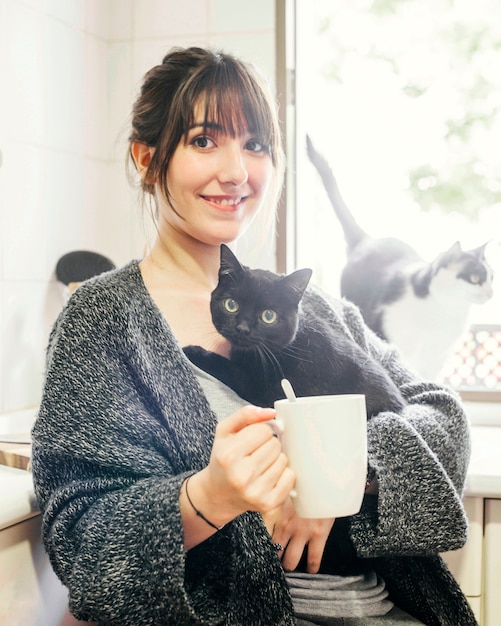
top-left (129, 47), bottom-right (284, 207)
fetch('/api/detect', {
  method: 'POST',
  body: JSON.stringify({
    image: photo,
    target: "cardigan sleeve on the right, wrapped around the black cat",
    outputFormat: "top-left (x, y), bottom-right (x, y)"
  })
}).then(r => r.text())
top-left (302, 290), bottom-right (470, 557)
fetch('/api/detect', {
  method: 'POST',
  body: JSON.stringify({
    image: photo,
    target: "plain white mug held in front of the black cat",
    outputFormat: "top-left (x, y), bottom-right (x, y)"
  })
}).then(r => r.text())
top-left (275, 394), bottom-right (367, 518)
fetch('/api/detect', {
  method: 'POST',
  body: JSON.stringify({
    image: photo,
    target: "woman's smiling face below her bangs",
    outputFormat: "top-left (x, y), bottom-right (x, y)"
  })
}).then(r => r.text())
top-left (159, 103), bottom-right (273, 245)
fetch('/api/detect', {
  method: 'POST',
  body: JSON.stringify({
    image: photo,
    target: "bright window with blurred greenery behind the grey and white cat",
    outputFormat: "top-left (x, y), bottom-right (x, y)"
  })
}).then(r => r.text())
top-left (288, 0), bottom-right (501, 398)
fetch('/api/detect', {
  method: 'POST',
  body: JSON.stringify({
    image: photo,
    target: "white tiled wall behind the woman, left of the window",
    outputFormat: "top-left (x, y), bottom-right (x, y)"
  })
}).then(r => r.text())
top-left (0, 0), bottom-right (275, 411)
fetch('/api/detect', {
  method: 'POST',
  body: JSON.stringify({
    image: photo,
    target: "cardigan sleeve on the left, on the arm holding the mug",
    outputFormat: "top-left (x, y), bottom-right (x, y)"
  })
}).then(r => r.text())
top-left (32, 287), bottom-right (215, 624)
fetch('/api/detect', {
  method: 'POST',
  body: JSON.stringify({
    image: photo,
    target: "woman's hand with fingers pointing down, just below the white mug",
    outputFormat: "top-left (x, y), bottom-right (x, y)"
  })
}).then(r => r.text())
top-left (264, 499), bottom-right (335, 574)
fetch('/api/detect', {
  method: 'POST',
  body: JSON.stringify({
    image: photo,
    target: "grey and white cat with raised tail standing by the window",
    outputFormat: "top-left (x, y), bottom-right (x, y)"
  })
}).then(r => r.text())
top-left (307, 137), bottom-right (493, 380)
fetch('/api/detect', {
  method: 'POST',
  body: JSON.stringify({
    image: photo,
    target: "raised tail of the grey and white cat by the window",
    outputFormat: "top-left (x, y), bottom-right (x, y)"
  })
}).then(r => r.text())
top-left (306, 135), bottom-right (368, 251)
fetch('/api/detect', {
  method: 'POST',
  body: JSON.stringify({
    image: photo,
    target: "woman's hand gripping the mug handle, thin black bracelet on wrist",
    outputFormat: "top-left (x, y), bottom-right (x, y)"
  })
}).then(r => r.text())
top-left (181, 406), bottom-right (296, 549)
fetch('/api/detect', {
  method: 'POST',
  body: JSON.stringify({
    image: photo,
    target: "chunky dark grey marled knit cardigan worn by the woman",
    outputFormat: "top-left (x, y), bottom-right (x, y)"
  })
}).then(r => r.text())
top-left (32, 261), bottom-right (476, 626)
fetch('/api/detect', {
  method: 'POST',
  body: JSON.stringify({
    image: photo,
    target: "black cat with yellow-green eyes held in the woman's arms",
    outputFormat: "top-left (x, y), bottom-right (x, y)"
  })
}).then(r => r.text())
top-left (184, 244), bottom-right (405, 417)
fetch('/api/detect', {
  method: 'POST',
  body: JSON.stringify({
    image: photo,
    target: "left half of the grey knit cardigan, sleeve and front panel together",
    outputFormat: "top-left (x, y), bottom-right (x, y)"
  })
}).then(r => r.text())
top-left (32, 274), bottom-right (292, 626)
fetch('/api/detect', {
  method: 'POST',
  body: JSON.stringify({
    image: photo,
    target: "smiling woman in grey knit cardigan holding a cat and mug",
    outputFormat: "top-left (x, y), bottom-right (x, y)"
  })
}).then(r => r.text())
top-left (32, 48), bottom-right (475, 626)
